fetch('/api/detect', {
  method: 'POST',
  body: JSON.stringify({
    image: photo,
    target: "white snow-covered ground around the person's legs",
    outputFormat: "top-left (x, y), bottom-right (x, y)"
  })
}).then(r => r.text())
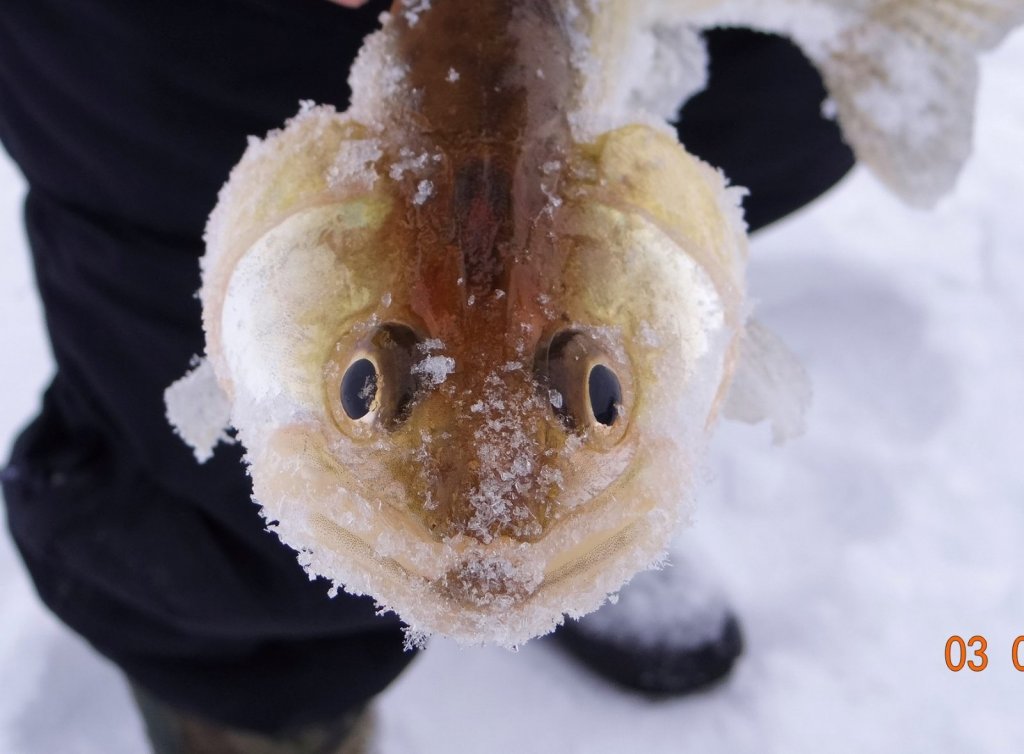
top-left (0, 33), bottom-right (1024, 754)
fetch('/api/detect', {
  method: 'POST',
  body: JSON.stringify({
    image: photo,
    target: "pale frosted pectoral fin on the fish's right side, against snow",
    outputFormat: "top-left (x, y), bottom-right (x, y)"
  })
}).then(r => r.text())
top-left (723, 320), bottom-right (811, 445)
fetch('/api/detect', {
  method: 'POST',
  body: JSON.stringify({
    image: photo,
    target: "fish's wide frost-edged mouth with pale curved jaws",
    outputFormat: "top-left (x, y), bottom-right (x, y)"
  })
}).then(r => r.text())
top-left (251, 426), bottom-right (667, 646)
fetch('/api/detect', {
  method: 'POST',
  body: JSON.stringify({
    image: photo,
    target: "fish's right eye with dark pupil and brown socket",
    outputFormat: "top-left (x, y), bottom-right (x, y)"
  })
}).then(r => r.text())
top-left (535, 330), bottom-right (632, 447)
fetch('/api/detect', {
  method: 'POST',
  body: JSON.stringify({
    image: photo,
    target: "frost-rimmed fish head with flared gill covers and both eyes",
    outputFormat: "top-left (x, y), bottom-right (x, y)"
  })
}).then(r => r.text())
top-left (197, 113), bottom-right (743, 644)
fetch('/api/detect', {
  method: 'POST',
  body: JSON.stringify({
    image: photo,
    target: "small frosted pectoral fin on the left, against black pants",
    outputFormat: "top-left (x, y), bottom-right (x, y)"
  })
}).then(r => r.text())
top-left (164, 359), bottom-right (234, 463)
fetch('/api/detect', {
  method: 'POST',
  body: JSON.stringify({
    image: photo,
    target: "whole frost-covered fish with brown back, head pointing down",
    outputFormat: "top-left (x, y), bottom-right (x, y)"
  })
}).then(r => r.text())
top-left (166, 0), bottom-right (1024, 646)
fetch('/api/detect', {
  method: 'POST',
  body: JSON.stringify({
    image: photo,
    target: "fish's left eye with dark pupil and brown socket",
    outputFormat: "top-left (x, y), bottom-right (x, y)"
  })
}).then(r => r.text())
top-left (324, 323), bottom-right (422, 435)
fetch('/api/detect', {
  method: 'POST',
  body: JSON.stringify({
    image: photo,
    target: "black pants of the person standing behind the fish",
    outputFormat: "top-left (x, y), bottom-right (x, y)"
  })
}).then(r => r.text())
top-left (0, 0), bottom-right (852, 731)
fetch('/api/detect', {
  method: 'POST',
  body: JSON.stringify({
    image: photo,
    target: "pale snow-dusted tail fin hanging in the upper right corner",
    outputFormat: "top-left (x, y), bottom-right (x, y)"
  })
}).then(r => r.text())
top-left (798, 0), bottom-right (1024, 207)
